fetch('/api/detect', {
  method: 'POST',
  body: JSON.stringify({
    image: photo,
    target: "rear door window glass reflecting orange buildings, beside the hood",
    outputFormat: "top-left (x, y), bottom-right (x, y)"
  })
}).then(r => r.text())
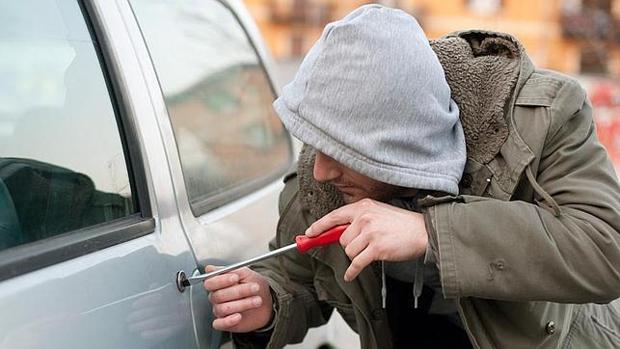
top-left (130, 0), bottom-right (290, 215)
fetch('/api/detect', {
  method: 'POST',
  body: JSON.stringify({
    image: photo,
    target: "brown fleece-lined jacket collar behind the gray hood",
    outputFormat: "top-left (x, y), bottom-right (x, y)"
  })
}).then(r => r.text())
top-left (433, 30), bottom-right (535, 200)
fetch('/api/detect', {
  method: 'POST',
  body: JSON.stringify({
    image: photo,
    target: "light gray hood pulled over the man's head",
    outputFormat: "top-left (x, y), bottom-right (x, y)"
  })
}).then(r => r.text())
top-left (274, 5), bottom-right (466, 194)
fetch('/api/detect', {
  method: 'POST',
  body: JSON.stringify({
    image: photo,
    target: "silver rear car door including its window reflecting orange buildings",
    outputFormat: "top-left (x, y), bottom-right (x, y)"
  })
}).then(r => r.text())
top-left (127, 0), bottom-right (293, 347)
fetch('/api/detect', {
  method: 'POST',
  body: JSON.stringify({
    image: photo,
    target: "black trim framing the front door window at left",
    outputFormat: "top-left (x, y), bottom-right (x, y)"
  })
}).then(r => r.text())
top-left (0, 0), bottom-right (155, 281)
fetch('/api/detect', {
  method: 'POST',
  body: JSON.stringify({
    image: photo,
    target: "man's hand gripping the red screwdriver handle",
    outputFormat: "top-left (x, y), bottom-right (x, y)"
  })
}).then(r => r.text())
top-left (306, 199), bottom-right (428, 281)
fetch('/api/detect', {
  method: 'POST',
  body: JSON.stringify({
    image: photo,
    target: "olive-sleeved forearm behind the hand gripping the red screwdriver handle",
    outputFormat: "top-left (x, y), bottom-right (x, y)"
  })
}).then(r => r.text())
top-left (427, 197), bottom-right (620, 303)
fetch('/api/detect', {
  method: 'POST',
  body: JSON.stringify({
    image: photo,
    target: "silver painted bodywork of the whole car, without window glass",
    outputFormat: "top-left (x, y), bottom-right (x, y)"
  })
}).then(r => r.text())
top-left (0, 0), bottom-right (352, 349)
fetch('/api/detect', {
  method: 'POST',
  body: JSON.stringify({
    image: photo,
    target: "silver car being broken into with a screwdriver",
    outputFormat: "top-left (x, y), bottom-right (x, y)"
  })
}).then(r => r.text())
top-left (0, 0), bottom-right (356, 348)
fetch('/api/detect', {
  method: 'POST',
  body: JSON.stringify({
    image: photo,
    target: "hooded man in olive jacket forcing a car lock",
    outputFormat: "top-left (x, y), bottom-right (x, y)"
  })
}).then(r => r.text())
top-left (205, 5), bottom-right (620, 348)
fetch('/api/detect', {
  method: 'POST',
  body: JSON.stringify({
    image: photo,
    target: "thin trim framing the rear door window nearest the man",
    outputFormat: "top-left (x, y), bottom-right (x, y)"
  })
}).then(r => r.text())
top-left (128, 0), bottom-right (295, 217)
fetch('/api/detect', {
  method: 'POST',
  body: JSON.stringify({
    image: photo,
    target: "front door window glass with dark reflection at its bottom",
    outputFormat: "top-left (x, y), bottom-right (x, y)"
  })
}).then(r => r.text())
top-left (0, 0), bottom-right (137, 250)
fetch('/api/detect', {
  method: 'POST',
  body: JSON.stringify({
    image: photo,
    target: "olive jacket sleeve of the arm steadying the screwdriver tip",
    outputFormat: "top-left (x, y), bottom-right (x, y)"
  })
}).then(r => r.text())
top-left (233, 178), bottom-right (333, 348)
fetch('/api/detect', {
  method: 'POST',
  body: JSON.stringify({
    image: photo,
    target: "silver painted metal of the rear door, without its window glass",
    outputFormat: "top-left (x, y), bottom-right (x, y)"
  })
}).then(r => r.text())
top-left (117, 1), bottom-right (294, 346)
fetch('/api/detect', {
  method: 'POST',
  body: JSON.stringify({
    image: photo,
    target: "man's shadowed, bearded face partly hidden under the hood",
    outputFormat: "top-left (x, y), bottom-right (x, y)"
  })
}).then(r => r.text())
top-left (313, 151), bottom-right (415, 204)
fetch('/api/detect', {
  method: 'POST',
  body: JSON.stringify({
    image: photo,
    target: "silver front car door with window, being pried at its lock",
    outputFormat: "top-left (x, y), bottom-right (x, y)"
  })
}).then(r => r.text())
top-left (0, 0), bottom-right (196, 348)
